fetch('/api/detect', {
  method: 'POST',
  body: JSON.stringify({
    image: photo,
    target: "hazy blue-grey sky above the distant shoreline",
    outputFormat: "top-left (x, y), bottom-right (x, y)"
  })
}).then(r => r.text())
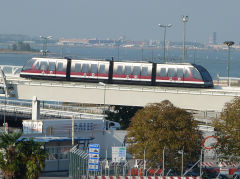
top-left (0, 0), bottom-right (240, 43)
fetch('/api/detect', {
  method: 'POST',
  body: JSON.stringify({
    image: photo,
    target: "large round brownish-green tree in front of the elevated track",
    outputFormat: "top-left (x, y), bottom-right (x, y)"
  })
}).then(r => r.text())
top-left (127, 101), bottom-right (202, 169)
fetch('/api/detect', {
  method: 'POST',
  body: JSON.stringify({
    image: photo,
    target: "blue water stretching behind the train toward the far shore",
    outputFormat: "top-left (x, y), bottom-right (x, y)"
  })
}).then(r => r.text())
top-left (0, 47), bottom-right (240, 79)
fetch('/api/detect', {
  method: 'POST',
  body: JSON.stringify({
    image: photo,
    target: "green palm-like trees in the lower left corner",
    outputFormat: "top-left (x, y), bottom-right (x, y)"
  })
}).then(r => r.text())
top-left (0, 133), bottom-right (47, 179)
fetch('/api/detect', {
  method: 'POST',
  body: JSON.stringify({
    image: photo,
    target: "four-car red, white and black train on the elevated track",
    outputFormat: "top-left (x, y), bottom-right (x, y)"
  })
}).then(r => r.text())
top-left (20, 57), bottom-right (213, 88)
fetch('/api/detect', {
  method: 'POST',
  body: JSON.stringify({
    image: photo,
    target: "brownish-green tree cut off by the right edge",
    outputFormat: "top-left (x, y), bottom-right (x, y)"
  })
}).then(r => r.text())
top-left (213, 97), bottom-right (240, 161)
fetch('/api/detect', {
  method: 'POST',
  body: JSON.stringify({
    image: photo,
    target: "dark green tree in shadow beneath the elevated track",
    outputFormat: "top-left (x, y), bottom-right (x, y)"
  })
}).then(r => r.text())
top-left (106, 105), bottom-right (142, 129)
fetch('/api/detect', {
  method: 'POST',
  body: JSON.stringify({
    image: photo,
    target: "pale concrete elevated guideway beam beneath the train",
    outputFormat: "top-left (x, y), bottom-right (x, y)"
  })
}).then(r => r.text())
top-left (1, 64), bottom-right (240, 112)
